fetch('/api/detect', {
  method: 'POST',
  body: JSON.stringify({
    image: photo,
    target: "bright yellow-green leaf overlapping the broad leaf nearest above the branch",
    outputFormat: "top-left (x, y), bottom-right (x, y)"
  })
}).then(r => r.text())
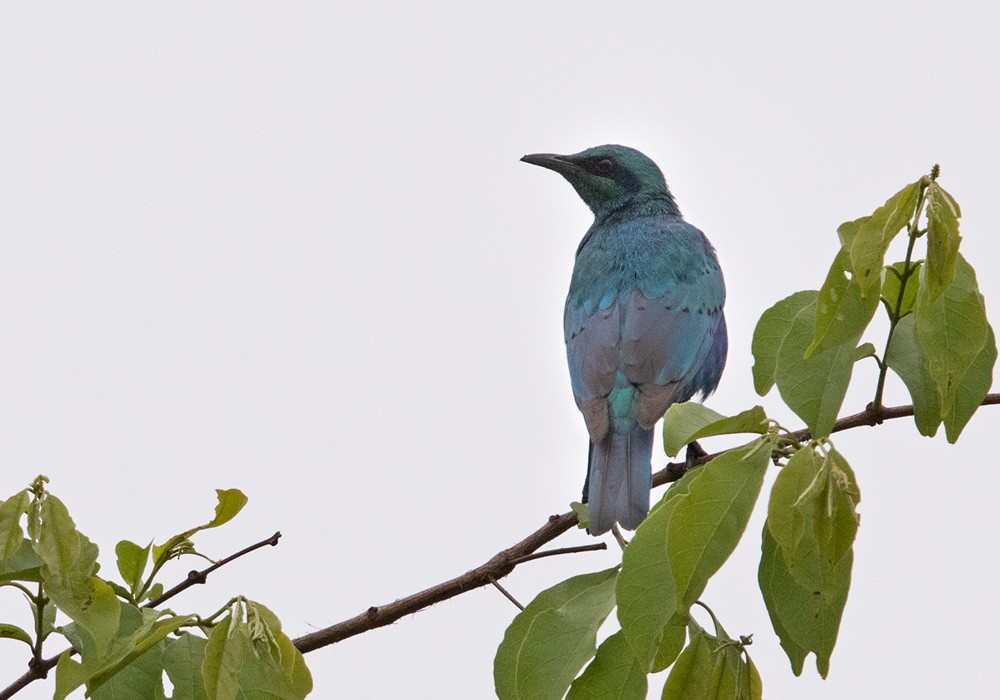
top-left (805, 250), bottom-right (881, 357)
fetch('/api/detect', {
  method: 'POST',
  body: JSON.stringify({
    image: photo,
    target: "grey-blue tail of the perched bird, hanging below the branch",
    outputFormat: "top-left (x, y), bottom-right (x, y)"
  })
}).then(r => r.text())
top-left (586, 425), bottom-right (653, 535)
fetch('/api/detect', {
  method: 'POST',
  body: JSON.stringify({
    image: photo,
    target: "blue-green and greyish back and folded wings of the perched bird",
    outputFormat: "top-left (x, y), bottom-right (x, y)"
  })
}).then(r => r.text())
top-left (564, 214), bottom-right (725, 440)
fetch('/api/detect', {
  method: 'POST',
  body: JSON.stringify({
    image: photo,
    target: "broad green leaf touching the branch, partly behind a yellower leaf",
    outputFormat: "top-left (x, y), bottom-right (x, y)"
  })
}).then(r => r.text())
top-left (775, 292), bottom-right (860, 437)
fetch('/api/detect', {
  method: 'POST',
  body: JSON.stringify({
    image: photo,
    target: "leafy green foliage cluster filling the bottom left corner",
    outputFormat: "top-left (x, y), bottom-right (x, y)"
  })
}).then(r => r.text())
top-left (0, 476), bottom-right (312, 700)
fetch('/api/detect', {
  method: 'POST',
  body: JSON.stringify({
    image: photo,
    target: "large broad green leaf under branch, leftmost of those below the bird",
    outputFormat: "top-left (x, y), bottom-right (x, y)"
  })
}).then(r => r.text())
top-left (492, 568), bottom-right (618, 700)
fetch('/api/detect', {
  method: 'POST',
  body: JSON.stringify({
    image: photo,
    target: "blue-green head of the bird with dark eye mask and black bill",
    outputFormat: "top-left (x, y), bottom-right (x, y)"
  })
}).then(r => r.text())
top-left (521, 145), bottom-right (679, 219)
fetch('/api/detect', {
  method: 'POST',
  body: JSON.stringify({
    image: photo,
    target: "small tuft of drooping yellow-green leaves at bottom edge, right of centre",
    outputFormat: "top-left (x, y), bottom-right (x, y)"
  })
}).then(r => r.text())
top-left (662, 625), bottom-right (763, 700)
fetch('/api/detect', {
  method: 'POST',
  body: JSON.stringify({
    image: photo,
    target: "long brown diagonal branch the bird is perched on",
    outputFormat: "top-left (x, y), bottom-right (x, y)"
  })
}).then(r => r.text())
top-left (294, 394), bottom-right (1000, 652)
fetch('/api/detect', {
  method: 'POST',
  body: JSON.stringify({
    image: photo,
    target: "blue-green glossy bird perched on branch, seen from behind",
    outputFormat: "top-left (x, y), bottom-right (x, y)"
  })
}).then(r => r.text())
top-left (521, 144), bottom-right (729, 535)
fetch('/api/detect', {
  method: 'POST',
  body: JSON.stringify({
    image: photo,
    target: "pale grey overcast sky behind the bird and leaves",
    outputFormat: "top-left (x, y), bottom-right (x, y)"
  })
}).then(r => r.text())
top-left (0, 1), bottom-right (1000, 699)
